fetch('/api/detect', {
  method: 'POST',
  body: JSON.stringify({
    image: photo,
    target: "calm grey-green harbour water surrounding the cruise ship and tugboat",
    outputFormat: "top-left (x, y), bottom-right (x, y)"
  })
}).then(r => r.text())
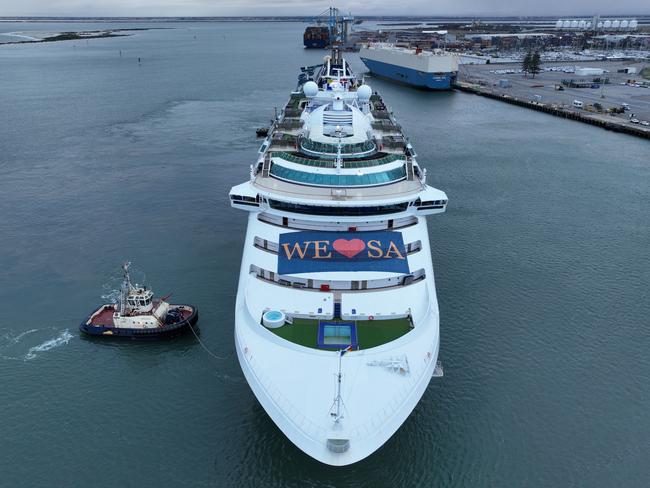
top-left (0, 23), bottom-right (650, 488)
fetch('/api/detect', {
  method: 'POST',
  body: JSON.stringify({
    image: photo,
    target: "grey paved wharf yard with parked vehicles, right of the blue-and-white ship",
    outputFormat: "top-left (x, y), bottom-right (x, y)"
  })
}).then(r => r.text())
top-left (459, 61), bottom-right (650, 125)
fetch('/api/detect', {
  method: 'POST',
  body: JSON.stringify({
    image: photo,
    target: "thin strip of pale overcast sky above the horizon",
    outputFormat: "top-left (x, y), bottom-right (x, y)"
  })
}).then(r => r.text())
top-left (5, 0), bottom-right (650, 16)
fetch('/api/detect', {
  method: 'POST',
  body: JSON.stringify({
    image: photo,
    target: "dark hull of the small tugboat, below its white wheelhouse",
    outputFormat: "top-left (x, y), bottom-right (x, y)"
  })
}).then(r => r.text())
top-left (79, 305), bottom-right (199, 339)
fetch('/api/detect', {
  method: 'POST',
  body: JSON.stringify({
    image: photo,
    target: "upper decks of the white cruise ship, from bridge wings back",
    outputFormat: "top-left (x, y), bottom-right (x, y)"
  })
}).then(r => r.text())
top-left (231, 52), bottom-right (447, 215)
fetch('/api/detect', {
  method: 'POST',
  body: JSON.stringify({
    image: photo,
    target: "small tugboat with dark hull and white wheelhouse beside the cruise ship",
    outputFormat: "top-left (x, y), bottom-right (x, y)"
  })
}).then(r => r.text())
top-left (79, 262), bottom-right (199, 339)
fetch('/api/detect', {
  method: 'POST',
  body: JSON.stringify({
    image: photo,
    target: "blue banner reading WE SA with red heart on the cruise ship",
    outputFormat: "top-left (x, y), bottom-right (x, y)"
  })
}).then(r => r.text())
top-left (278, 231), bottom-right (409, 274)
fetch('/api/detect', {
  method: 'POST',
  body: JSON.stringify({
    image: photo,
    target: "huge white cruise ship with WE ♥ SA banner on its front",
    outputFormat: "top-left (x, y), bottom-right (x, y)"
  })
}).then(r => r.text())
top-left (230, 51), bottom-right (447, 466)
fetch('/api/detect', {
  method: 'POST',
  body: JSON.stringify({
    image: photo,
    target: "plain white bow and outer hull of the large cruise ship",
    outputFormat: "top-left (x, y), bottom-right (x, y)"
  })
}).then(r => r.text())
top-left (234, 214), bottom-right (440, 466)
